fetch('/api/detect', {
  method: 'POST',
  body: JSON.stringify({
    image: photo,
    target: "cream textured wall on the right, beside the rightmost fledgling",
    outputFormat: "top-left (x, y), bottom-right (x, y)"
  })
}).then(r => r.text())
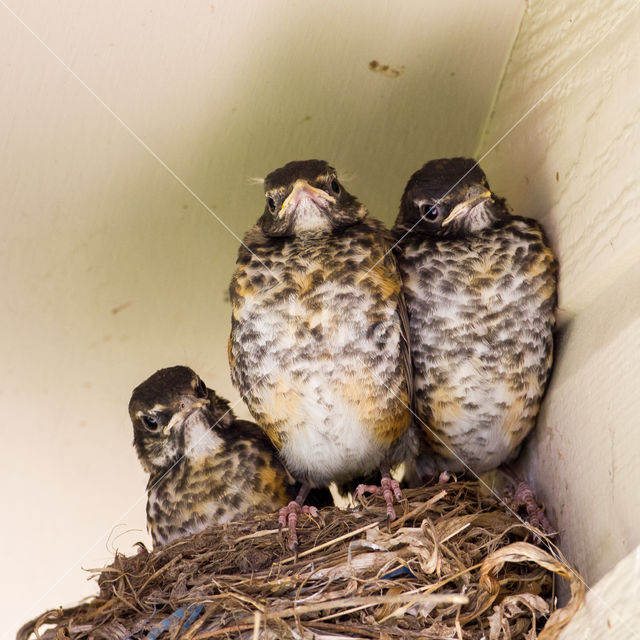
top-left (479, 0), bottom-right (640, 592)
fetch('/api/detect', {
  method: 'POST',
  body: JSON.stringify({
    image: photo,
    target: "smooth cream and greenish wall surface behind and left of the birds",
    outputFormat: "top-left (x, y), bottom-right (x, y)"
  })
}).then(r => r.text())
top-left (0, 0), bottom-right (524, 636)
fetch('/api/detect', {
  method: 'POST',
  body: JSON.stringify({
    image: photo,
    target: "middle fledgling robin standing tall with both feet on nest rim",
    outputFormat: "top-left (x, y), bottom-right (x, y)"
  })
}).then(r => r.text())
top-left (229, 160), bottom-right (411, 548)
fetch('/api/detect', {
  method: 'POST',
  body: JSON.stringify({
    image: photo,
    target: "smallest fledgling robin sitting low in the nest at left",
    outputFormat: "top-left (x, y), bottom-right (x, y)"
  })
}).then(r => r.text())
top-left (129, 366), bottom-right (294, 546)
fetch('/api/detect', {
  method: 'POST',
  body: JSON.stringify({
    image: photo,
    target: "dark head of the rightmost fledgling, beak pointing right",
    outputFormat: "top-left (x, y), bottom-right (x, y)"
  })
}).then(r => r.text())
top-left (395, 158), bottom-right (508, 237)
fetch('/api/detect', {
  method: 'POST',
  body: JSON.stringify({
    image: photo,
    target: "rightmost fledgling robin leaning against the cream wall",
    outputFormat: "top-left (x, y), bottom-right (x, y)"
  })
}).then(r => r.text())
top-left (393, 158), bottom-right (557, 496)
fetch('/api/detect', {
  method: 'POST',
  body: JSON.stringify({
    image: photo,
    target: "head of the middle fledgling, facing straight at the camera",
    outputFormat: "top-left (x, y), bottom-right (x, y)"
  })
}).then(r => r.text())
top-left (259, 160), bottom-right (367, 236)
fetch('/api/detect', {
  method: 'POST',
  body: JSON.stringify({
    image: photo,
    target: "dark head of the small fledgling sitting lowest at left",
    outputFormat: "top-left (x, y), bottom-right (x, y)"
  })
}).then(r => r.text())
top-left (129, 366), bottom-right (235, 473)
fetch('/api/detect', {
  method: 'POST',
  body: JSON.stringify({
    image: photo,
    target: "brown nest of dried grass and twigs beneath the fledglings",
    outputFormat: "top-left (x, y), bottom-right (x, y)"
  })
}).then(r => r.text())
top-left (17, 482), bottom-right (584, 640)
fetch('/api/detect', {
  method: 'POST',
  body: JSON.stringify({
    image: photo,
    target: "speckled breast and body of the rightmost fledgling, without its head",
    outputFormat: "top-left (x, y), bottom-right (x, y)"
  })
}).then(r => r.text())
top-left (398, 217), bottom-right (556, 472)
